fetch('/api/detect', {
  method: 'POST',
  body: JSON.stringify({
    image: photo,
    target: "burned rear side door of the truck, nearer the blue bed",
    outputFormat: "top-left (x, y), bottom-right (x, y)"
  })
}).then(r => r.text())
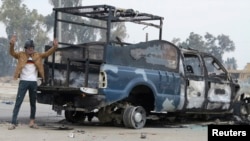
top-left (184, 53), bottom-right (205, 110)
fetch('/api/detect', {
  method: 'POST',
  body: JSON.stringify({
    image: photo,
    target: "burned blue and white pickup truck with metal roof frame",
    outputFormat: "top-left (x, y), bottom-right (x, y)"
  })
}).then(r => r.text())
top-left (37, 5), bottom-right (250, 129)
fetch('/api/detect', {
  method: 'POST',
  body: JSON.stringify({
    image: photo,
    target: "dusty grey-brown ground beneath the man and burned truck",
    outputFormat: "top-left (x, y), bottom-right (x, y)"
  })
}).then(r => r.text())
top-left (0, 80), bottom-right (207, 141)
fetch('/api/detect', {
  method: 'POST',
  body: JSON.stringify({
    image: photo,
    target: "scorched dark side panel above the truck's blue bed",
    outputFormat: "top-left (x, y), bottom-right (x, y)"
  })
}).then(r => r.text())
top-left (107, 41), bottom-right (179, 72)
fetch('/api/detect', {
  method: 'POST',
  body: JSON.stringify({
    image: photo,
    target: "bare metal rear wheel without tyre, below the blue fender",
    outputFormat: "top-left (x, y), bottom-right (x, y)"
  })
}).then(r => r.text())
top-left (123, 106), bottom-right (147, 129)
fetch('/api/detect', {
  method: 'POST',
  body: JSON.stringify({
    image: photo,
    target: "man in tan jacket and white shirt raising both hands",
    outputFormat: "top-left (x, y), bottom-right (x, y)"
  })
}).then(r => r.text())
top-left (8, 35), bottom-right (58, 130)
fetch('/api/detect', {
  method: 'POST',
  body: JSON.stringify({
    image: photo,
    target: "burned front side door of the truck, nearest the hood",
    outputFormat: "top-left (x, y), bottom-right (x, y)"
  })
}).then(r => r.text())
top-left (204, 55), bottom-right (232, 111)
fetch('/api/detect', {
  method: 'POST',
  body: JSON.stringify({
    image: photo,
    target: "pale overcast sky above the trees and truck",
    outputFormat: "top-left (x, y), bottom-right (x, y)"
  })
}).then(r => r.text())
top-left (0, 0), bottom-right (250, 69)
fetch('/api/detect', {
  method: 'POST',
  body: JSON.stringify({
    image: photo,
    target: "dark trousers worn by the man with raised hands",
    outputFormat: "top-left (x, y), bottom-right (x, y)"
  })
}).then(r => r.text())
top-left (11, 80), bottom-right (37, 125)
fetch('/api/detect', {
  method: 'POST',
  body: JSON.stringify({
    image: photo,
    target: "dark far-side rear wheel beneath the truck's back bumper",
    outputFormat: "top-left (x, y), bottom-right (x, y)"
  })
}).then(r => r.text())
top-left (64, 110), bottom-right (86, 123)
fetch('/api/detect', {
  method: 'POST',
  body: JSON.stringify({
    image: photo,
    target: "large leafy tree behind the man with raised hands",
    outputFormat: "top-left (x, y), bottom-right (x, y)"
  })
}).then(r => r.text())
top-left (0, 0), bottom-right (49, 75)
